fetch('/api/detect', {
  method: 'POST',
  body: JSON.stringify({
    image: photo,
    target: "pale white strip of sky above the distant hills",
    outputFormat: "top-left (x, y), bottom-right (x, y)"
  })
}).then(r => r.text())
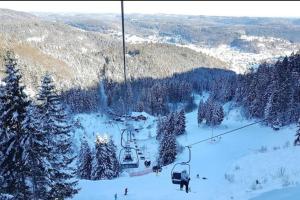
top-left (0, 1), bottom-right (300, 17)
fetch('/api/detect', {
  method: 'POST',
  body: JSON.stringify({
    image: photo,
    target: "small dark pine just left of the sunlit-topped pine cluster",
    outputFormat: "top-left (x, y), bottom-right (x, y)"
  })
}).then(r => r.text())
top-left (77, 139), bottom-right (93, 180)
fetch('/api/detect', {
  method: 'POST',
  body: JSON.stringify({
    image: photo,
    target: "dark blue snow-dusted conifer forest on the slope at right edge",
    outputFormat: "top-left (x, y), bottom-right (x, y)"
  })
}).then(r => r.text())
top-left (235, 53), bottom-right (300, 126)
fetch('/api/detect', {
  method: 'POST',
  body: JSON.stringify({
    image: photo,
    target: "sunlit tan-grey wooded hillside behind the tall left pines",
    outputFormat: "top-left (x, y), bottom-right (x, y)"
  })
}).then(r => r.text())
top-left (0, 9), bottom-right (228, 95)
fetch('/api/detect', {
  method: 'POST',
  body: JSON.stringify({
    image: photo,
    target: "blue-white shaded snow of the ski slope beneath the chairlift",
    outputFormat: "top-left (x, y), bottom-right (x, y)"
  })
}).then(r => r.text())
top-left (74, 95), bottom-right (300, 200)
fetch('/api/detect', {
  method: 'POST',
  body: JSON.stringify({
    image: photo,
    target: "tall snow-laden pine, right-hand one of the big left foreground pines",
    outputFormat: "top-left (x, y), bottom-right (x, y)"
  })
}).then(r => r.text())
top-left (38, 74), bottom-right (78, 199)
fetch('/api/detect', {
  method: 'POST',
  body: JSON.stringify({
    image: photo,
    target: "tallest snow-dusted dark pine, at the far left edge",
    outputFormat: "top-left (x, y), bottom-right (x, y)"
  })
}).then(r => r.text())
top-left (0, 52), bottom-right (31, 199)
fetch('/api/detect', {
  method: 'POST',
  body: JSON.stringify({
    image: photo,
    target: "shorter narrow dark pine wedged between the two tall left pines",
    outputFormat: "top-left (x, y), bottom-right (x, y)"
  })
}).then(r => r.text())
top-left (23, 103), bottom-right (52, 200)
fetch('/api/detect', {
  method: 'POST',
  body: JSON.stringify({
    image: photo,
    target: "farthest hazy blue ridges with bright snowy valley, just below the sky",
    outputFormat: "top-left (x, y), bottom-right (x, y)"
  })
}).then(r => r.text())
top-left (38, 13), bottom-right (300, 73)
